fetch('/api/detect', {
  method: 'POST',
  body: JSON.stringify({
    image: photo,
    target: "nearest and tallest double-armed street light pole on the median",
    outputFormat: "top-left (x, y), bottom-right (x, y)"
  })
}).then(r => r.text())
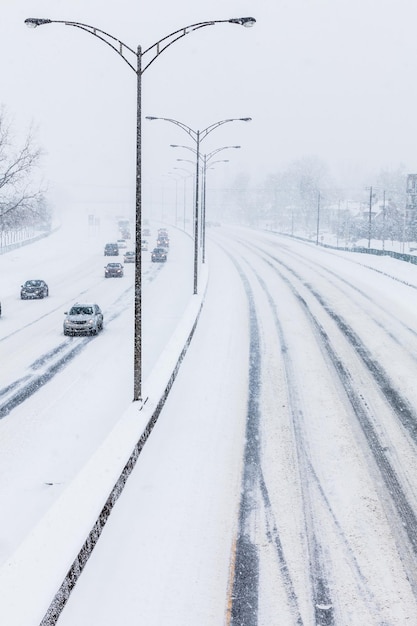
top-left (25, 17), bottom-right (256, 401)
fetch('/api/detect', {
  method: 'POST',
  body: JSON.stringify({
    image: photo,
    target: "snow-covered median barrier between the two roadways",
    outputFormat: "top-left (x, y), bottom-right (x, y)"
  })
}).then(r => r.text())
top-left (0, 268), bottom-right (207, 626)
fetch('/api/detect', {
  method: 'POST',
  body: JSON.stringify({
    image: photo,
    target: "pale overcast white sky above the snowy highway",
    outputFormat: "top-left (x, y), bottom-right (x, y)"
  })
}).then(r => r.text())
top-left (0, 0), bottom-right (417, 214)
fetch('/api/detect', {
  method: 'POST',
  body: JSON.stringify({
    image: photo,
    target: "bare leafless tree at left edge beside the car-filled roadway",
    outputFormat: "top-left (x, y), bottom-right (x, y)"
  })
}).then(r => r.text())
top-left (0, 109), bottom-right (51, 241)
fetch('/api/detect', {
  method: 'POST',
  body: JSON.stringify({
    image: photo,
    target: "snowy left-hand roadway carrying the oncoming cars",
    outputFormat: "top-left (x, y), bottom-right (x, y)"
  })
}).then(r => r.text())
top-left (0, 220), bottom-right (193, 562)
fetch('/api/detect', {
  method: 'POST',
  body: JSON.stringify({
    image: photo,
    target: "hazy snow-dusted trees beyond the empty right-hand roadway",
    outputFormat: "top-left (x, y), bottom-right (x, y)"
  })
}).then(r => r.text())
top-left (227, 157), bottom-right (417, 245)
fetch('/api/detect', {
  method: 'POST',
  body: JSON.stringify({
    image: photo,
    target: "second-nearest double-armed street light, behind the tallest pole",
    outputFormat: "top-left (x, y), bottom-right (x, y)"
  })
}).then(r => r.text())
top-left (146, 115), bottom-right (252, 295)
